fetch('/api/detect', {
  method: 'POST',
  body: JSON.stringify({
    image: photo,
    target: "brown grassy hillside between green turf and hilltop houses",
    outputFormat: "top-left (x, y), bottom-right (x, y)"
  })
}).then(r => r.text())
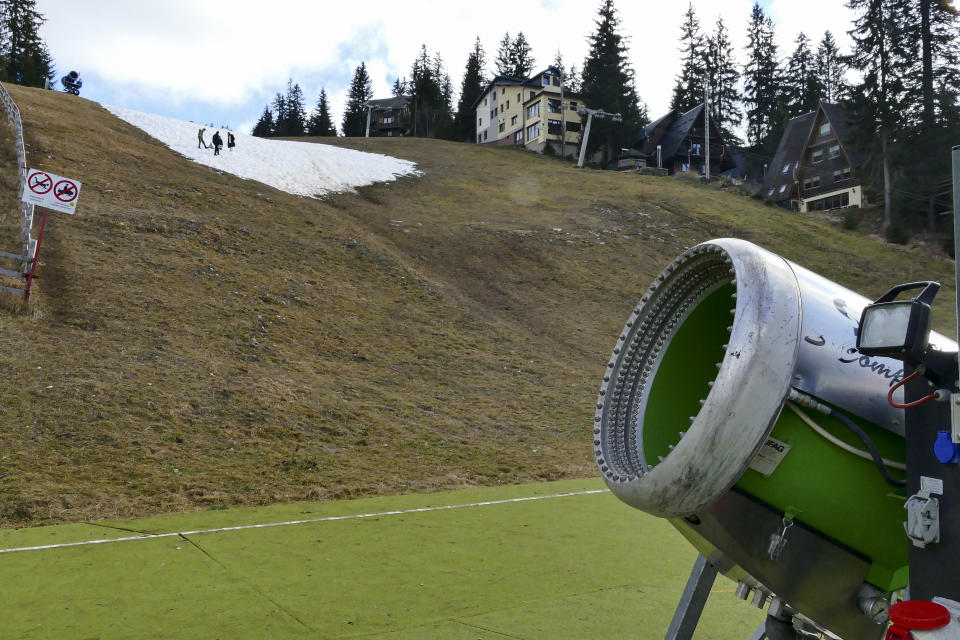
top-left (0, 87), bottom-right (952, 526)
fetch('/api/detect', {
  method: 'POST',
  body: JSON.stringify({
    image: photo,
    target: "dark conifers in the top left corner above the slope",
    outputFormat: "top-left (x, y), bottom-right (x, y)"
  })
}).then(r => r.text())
top-left (0, 0), bottom-right (55, 87)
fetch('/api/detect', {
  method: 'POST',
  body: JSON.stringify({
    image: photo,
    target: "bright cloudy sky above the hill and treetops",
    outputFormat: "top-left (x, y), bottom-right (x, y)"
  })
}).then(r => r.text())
top-left (37, 0), bottom-right (851, 132)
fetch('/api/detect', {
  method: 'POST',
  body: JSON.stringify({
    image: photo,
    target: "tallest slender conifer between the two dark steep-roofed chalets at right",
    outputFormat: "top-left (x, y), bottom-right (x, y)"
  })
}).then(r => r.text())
top-left (743, 2), bottom-right (781, 145)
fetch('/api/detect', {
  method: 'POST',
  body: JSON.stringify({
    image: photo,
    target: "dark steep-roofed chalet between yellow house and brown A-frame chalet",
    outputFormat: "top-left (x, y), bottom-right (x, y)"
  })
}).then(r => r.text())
top-left (632, 104), bottom-right (734, 175)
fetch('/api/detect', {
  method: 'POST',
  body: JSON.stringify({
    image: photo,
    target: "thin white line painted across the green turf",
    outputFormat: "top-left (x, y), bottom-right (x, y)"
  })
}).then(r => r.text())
top-left (0, 489), bottom-right (607, 553)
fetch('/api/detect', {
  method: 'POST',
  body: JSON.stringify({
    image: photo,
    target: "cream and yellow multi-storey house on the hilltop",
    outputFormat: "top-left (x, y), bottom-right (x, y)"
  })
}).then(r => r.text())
top-left (473, 67), bottom-right (583, 156)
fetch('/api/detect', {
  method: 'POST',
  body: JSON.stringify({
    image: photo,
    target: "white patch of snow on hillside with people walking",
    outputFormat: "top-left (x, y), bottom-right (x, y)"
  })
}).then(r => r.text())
top-left (103, 105), bottom-right (420, 197)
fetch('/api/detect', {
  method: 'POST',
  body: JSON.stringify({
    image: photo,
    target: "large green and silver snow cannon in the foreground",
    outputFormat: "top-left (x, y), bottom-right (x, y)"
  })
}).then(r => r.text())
top-left (593, 238), bottom-right (956, 640)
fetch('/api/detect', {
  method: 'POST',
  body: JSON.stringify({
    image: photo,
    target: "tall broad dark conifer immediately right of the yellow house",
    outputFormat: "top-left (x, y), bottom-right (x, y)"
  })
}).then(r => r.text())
top-left (581, 0), bottom-right (646, 164)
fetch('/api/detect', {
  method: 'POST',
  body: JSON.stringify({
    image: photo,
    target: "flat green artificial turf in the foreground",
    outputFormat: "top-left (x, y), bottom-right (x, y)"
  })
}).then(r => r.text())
top-left (0, 480), bottom-right (762, 640)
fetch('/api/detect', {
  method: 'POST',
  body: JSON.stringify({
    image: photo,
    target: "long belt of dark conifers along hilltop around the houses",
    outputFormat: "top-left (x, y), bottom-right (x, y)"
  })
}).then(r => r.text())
top-left (254, 0), bottom-right (960, 239)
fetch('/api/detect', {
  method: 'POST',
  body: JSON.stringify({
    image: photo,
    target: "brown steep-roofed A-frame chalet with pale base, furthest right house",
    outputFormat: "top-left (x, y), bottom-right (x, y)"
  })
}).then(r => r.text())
top-left (762, 102), bottom-right (863, 211)
